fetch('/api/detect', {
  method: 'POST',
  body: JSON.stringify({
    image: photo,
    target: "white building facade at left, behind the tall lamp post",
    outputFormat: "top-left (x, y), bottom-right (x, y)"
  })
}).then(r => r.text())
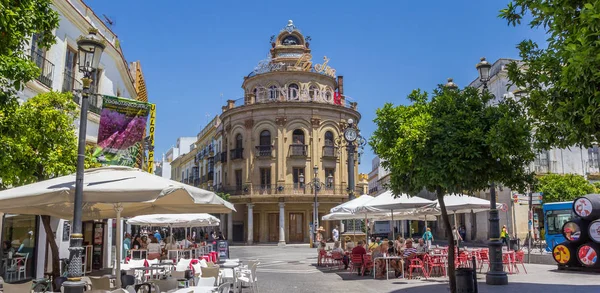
top-left (2, 0), bottom-right (137, 278)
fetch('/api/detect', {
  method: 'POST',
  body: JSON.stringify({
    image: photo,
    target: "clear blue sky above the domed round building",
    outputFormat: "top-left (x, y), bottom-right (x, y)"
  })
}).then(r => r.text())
top-left (86, 0), bottom-right (544, 173)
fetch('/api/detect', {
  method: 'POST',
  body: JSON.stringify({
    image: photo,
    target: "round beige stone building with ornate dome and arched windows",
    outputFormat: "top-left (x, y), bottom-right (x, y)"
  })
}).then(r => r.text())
top-left (215, 24), bottom-right (360, 244)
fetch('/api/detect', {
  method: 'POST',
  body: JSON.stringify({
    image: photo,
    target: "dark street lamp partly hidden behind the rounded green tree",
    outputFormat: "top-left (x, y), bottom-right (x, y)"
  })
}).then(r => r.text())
top-left (475, 57), bottom-right (508, 285)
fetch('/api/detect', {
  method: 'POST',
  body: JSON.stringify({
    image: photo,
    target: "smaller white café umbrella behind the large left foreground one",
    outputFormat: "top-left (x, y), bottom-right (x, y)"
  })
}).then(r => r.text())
top-left (127, 214), bottom-right (221, 228)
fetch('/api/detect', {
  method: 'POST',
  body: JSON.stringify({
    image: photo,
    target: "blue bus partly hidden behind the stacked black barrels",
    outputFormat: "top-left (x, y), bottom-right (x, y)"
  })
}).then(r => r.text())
top-left (542, 201), bottom-right (575, 251)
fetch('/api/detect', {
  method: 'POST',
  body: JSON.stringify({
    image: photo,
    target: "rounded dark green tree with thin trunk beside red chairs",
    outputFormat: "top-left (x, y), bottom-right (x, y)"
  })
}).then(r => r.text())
top-left (370, 86), bottom-right (535, 292)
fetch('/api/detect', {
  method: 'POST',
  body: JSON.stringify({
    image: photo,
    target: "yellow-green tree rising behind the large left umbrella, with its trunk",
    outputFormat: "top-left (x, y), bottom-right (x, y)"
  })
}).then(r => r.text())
top-left (0, 92), bottom-right (100, 277)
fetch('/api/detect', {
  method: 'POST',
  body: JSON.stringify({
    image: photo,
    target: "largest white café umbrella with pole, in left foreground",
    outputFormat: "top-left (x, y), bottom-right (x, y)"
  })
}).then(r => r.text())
top-left (0, 166), bottom-right (235, 286)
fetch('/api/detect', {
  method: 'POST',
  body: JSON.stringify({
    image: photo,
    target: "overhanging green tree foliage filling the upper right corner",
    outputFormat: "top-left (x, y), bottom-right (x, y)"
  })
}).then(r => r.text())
top-left (500, 0), bottom-right (600, 148)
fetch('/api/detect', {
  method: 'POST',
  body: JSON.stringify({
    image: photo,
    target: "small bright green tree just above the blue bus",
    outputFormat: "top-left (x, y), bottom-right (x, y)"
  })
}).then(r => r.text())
top-left (537, 174), bottom-right (596, 202)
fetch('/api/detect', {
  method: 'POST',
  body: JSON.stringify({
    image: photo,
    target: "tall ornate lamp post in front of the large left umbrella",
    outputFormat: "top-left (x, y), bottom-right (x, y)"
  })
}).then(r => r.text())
top-left (63, 28), bottom-right (106, 293)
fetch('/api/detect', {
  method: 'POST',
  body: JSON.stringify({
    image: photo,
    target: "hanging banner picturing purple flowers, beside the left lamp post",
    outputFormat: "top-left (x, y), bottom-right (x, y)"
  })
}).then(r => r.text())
top-left (94, 96), bottom-right (150, 167)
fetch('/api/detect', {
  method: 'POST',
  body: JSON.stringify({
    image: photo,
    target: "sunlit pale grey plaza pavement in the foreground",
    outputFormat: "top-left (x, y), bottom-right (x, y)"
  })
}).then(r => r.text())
top-left (230, 245), bottom-right (600, 293)
